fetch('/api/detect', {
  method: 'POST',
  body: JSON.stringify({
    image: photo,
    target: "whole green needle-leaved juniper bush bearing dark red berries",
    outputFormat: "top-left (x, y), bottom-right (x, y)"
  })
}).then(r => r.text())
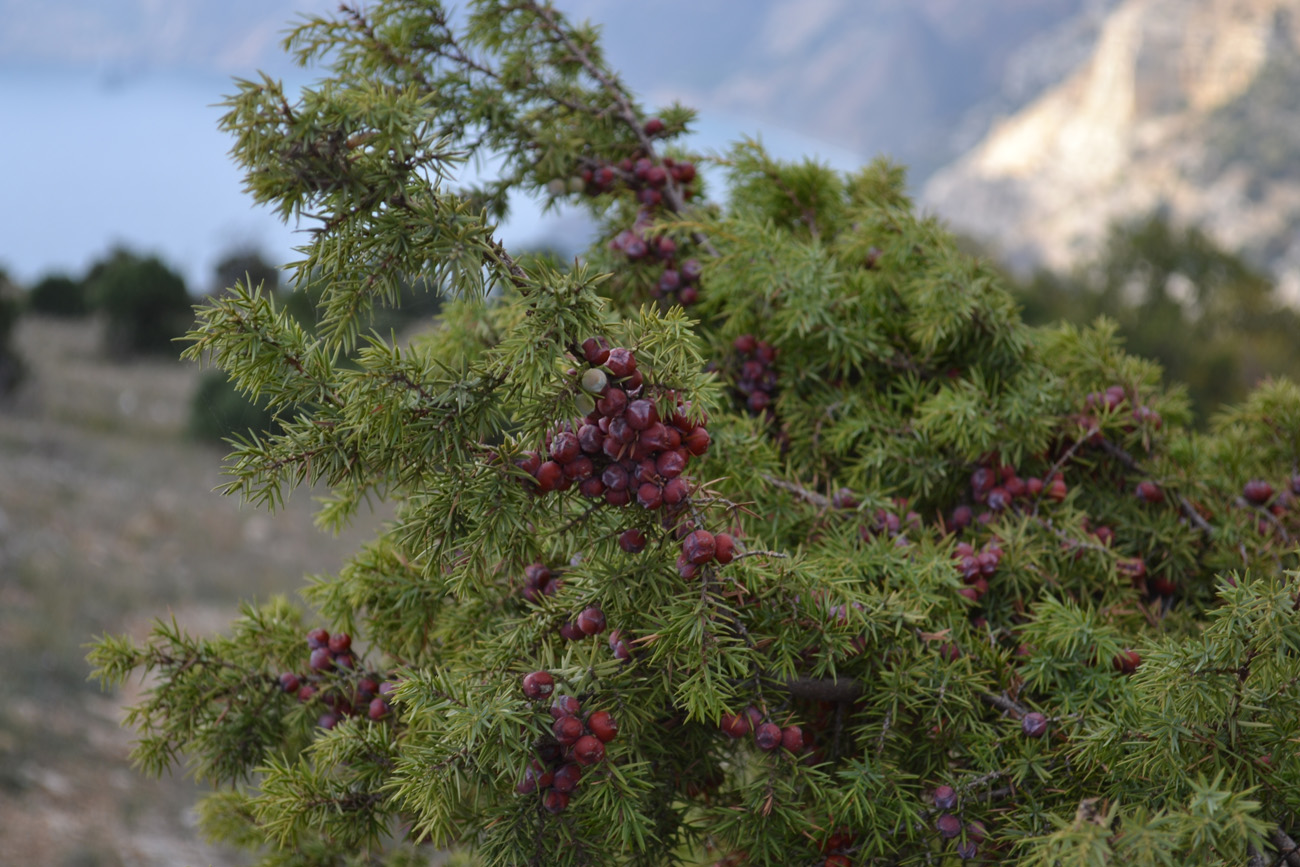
top-left (91, 0), bottom-right (1300, 867)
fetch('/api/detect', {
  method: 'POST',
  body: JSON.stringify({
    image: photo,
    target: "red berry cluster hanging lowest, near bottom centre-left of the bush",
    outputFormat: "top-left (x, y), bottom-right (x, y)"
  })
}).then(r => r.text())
top-left (515, 671), bottom-right (619, 814)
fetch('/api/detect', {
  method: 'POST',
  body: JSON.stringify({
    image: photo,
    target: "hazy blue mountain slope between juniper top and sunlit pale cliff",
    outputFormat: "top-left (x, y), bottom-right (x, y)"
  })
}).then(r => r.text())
top-left (572, 0), bottom-right (1114, 182)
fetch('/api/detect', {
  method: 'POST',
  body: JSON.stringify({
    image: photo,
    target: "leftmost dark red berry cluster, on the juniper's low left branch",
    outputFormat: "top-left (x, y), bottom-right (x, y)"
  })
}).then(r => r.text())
top-left (280, 629), bottom-right (397, 728)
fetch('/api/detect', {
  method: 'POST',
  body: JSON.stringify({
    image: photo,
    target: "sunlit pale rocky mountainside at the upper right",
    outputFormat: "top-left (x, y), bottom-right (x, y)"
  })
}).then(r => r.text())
top-left (920, 0), bottom-right (1300, 299)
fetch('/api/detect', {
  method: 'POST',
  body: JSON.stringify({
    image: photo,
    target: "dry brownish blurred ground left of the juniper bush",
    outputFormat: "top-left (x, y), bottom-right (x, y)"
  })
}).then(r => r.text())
top-left (0, 317), bottom-right (378, 867)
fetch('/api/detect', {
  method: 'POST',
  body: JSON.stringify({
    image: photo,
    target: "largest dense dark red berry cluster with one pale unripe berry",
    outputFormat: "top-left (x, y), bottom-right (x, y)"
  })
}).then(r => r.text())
top-left (516, 338), bottom-right (710, 510)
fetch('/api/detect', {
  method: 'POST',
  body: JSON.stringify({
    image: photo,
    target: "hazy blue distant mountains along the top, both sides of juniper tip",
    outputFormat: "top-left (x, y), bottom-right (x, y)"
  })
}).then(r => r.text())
top-left (0, 0), bottom-right (1113, 181)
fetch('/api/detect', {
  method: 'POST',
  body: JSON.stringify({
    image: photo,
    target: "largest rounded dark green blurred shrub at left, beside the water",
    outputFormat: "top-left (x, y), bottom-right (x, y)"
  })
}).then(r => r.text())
top-left (86, 250), bottom-right (194, 355)
